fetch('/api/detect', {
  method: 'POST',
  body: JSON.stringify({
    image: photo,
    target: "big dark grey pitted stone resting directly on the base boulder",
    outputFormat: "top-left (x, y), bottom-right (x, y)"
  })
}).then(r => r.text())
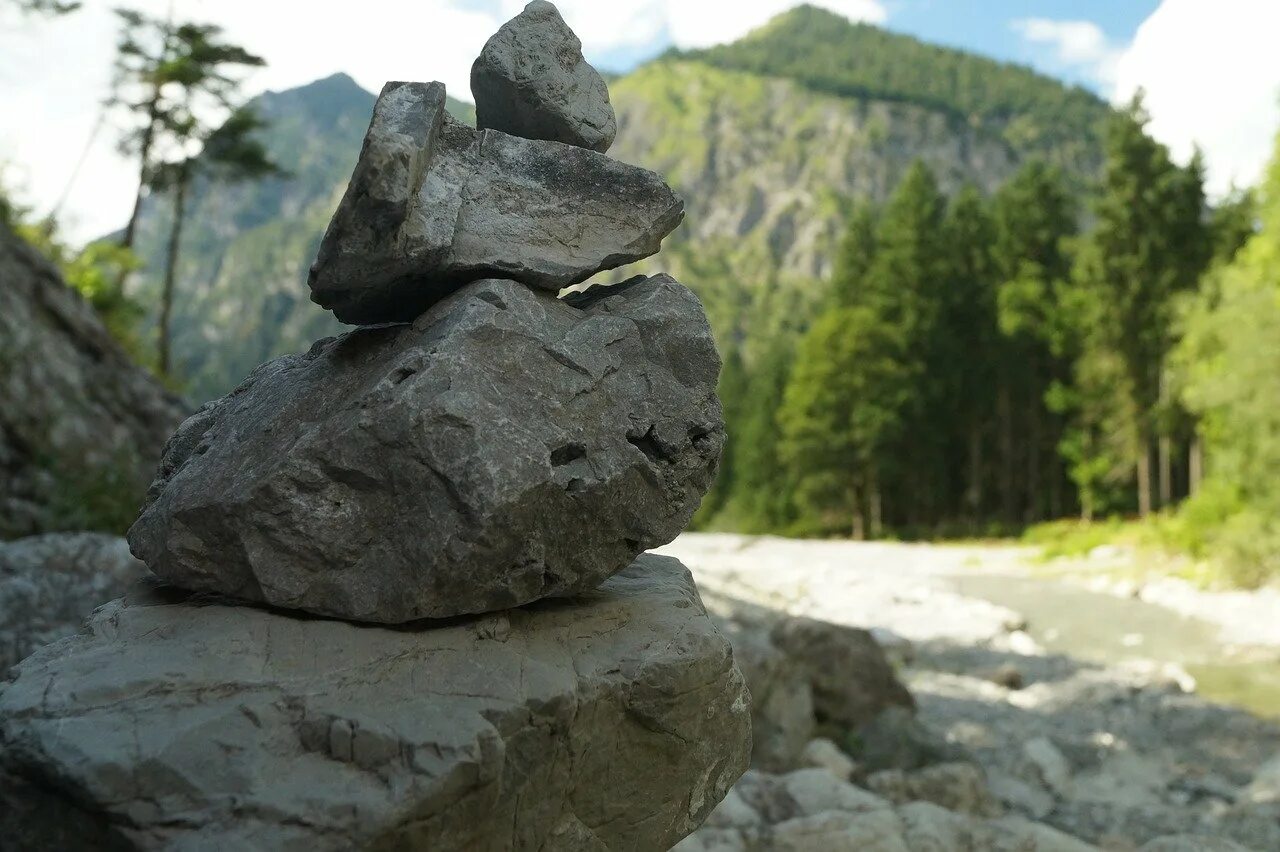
top-left (129, 276), bottom-right (724, 623)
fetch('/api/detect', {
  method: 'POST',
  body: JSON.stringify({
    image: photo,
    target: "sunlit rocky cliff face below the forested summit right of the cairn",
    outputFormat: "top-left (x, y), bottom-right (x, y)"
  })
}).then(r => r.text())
top-left (613, 61), bottom-right (1019, 343)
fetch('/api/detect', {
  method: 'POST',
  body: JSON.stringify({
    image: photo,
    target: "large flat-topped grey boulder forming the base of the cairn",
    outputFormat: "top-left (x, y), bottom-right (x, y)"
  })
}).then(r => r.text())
top-left (0, 555), bottom-right (750, 852)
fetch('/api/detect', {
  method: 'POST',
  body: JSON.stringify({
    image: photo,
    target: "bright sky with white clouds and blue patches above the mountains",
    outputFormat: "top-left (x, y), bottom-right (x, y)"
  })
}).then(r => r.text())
top-left (0, 0), bottom-right (1280, 241)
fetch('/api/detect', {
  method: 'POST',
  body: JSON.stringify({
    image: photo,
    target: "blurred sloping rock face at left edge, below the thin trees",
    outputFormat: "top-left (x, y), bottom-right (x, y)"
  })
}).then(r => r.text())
top-left (0, 225), bottom-right (186, 539)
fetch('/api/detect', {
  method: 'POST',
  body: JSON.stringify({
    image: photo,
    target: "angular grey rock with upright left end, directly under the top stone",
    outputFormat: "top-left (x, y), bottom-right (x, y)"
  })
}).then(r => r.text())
top-left (310, 83), bottom-right (685, 324)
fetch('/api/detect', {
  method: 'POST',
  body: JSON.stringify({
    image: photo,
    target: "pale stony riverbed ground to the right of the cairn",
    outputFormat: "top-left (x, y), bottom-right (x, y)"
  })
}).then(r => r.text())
top-left (663, 535), bottom-right (1280, 851)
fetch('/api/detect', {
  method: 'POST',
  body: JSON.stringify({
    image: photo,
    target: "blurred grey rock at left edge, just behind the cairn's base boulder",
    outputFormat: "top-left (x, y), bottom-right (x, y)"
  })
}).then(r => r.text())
top-left (0, 532), bottom-right (146, 674)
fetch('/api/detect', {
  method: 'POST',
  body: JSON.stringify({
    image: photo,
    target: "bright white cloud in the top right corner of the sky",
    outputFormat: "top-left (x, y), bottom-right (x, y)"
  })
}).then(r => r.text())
top-left (1114, 0), bottom-right (1280, 194)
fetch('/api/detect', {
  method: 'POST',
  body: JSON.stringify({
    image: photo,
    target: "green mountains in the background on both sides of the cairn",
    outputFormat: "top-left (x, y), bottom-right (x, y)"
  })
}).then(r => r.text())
top-left (127, 6), bottom-right (1108, 399)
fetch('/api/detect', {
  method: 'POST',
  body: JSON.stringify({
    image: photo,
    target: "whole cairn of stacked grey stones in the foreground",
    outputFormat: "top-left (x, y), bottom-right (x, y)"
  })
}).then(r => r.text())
top-left (0, 0), bottom-right (750, 852)
